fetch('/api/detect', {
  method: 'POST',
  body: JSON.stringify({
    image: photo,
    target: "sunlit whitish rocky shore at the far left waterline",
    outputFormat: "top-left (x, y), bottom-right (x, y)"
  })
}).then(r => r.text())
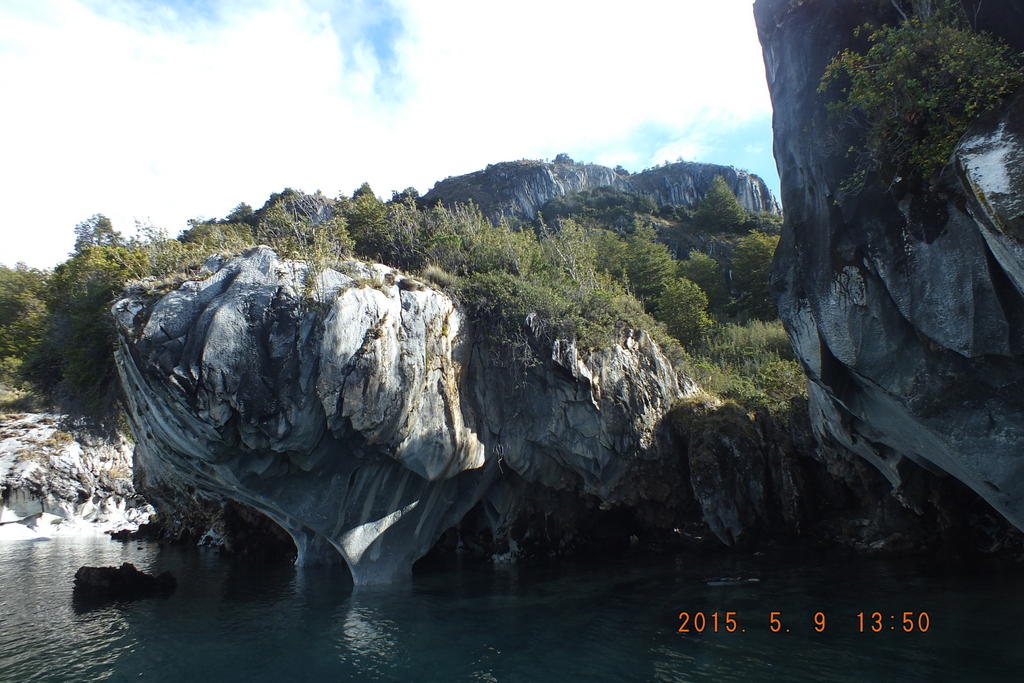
top-left (0, 414), bottom-right (154, 535)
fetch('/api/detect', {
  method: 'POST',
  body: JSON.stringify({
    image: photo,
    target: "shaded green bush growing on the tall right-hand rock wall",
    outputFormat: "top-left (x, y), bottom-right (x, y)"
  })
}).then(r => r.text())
top-left (818, 2), bottom-right (1024, 191)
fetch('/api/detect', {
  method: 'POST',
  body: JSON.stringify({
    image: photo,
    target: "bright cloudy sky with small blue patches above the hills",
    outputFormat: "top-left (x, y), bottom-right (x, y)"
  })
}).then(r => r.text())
top-left (0, 0), bottom-right (778, 268)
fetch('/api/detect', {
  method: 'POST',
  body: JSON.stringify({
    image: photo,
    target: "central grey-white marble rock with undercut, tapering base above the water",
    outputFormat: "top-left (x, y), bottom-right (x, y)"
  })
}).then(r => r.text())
top-left (114, 247), bottom-right (693, 584)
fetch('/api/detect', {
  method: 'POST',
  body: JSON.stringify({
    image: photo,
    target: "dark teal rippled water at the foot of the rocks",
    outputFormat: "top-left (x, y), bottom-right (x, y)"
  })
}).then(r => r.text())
top-left (0, 538), bottom-right (1024, 683)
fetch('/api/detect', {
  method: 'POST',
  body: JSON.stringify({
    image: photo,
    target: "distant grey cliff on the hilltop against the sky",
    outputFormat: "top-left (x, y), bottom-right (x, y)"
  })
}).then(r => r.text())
top-left (423, 161), bottom-right (779, 220)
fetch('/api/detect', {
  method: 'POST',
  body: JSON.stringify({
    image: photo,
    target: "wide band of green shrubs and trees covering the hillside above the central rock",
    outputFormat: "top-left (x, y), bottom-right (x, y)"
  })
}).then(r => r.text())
top-left (0, 168), bottom-right (803, 422)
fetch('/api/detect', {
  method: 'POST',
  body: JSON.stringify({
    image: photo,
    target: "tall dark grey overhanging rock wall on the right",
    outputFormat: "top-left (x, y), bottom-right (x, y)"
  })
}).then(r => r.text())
top-left (755, 0), bottom-right (1024, 528)
